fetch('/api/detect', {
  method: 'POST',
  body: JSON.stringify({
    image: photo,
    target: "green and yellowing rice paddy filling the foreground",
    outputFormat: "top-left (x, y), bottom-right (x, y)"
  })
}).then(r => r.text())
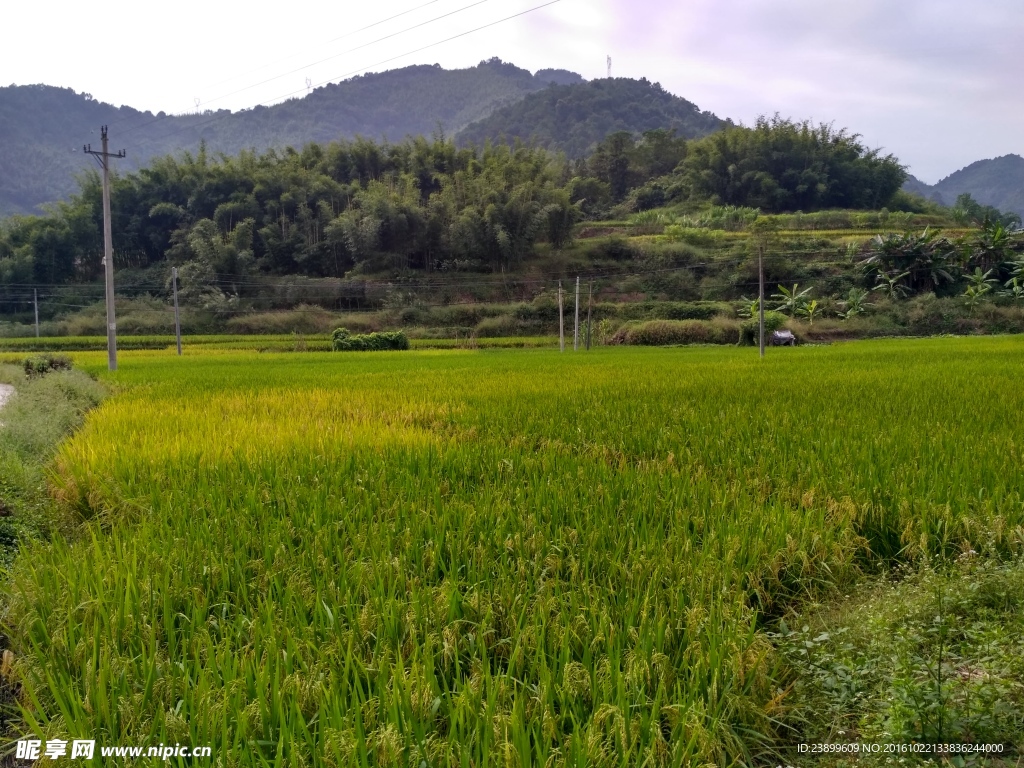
top-left (4, 337), bottom-right (1024, 766)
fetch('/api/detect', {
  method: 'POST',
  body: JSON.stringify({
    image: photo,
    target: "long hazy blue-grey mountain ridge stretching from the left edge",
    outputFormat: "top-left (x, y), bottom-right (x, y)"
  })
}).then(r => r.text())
top-left (0, 58), bottom-right (583, 217)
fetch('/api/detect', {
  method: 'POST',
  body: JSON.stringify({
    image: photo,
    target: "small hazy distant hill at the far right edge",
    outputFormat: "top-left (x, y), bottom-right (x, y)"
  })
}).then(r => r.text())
top-left (904, 155), bottom-right (1024, 217)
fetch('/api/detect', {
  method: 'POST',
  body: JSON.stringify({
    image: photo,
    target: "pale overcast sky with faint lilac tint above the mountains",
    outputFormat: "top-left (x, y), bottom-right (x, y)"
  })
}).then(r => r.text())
top-left (0, 0), bottom-right (1024, 182)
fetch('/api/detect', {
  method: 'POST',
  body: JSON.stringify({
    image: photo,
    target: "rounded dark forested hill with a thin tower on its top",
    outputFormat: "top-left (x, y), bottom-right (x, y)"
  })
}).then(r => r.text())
top-left (458, 78), bottom-right (727, 158)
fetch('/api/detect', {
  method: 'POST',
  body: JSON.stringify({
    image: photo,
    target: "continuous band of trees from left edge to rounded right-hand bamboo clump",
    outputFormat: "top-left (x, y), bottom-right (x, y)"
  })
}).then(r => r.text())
top-left (0, 119), bottom-right (925, 301)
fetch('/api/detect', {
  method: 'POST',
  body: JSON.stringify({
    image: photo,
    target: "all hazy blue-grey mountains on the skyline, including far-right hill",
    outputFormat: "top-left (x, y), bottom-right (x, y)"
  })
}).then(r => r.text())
top-left (0, 58), bottom-right (1024, 222)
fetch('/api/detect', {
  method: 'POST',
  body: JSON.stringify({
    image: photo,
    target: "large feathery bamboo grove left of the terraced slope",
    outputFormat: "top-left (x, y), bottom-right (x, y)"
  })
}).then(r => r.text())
top-left (0, 138), bottom-right (575, 288)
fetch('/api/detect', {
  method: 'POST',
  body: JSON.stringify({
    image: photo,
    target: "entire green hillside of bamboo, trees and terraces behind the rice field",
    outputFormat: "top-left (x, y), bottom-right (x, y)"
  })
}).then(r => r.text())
top-left (6, 118), bottom-right (1024, 343)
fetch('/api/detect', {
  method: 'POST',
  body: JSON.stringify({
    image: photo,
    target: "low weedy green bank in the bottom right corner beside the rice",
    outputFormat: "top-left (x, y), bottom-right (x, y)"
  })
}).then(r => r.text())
top-left (778, 552), bottom-right (1024, 766)
